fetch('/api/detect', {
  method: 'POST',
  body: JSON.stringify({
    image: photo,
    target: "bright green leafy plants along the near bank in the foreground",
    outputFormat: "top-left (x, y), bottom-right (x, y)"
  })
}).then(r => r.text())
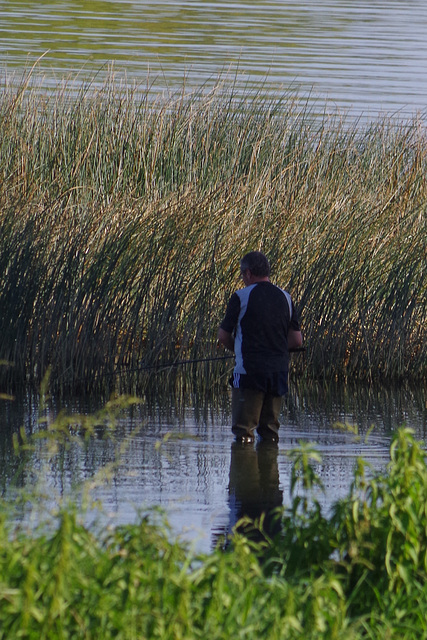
top-left (0, 403), bottom-right (427, 640)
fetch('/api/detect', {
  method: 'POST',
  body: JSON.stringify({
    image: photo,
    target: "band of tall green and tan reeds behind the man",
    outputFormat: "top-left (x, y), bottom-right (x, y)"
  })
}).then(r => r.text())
top-left (0, 75), bottom-right (427, 386)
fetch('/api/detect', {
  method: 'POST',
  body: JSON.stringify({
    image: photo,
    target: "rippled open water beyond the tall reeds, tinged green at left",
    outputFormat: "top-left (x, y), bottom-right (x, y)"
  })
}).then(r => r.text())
top-left (0, 0), bottom-right (427, 119)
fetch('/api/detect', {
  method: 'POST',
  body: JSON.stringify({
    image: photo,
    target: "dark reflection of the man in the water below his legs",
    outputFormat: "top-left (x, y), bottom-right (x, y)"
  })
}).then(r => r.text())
top-left (217, 441), bottom-right (283, 546)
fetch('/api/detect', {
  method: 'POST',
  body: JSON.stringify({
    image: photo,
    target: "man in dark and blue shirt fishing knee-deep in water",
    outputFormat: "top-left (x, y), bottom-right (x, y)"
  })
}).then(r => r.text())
top-left (218, 251), bottom-right (302, 442)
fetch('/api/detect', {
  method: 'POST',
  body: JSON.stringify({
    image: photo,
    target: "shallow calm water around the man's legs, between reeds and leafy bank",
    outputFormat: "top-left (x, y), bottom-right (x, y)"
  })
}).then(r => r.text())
top-left (0, 385), bottom-right (427, 552)
